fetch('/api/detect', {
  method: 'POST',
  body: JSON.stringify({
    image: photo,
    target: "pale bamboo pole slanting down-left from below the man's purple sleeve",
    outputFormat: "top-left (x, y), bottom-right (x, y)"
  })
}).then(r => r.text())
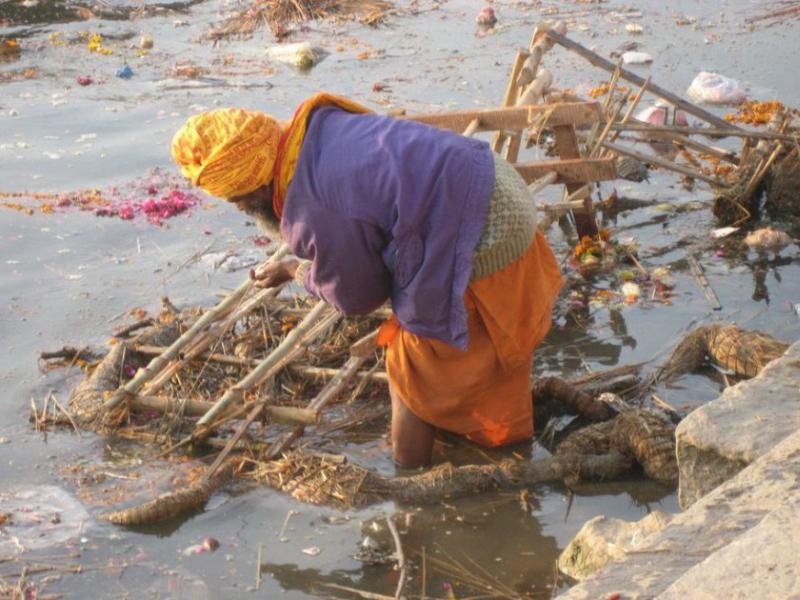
top-left (195, 300), bottom-right (339, 429)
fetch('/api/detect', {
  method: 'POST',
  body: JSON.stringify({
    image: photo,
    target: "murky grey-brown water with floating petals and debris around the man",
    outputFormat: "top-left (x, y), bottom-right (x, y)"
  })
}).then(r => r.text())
top-left (0, 0), bottom-right (800, 598)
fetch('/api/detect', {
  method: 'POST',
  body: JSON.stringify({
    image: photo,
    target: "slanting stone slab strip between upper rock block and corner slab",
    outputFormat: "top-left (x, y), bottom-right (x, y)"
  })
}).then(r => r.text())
top-left (559, 431), bottom-right (800, 600)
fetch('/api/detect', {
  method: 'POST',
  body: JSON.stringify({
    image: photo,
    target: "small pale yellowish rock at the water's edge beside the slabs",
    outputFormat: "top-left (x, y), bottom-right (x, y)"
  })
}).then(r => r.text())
top-left (558, 510), bottom-right (671, 581)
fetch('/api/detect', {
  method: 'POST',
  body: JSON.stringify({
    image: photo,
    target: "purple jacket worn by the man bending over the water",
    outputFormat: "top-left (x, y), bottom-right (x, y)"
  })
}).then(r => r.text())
top-left (281, 107), bottom-right (494, 350)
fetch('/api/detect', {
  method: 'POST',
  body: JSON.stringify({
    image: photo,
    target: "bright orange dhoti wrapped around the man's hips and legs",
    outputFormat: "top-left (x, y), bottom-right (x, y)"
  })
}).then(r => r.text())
top-left (382, 233), bottom-right (562, 446)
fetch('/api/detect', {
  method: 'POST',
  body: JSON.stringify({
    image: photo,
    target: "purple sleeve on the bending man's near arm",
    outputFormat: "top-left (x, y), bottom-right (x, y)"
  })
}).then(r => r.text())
top-left (283, 207), bottom-right (391, 315)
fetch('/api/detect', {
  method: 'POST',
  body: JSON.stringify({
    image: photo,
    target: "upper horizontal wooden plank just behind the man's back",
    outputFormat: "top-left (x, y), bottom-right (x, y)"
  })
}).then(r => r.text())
top-left (406, 102), bottom-right (600, 133)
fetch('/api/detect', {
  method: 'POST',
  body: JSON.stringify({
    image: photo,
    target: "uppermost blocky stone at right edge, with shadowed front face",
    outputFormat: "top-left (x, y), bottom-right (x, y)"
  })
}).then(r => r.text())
top-left (675, 342), bottom-right (800, 509)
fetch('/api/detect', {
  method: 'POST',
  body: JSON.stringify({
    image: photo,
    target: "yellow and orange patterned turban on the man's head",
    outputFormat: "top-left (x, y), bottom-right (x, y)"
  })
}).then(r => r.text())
top-left (172, 108), bottom-right (281, 199)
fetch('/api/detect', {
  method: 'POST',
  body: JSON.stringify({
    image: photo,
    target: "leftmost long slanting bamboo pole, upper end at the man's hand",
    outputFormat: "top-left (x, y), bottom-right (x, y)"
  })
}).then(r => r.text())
top-left (103, 244), bottom-right (289, 410)
